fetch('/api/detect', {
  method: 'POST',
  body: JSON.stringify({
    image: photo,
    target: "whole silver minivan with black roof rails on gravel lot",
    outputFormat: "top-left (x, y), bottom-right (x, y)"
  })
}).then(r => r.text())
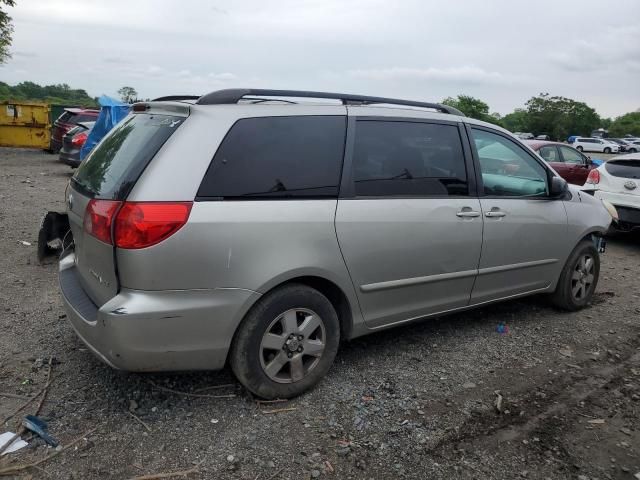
top-left (59, 89), bottom-right (615, 398)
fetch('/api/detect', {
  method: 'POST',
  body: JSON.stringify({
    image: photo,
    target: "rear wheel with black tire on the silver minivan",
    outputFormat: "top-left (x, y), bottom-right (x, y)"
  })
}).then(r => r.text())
top-left (230, 284), bottom-right (340, 399)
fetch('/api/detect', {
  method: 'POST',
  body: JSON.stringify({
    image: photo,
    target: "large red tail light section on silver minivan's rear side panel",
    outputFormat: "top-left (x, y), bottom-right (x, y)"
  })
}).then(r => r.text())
top-left (114, 202), bottom-right (193, 249)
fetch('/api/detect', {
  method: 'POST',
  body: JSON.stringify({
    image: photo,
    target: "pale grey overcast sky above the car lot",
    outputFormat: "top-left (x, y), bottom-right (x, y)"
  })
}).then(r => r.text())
top-left (0, 0), bottom-right (640, 116)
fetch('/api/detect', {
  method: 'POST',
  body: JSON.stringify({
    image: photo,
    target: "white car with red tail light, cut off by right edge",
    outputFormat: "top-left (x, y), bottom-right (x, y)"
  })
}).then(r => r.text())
top-left (582, 153), bottom-right (640, 231)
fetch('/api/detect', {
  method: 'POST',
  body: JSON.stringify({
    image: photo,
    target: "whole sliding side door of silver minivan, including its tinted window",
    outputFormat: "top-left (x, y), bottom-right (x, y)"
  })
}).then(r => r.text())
top-left (336, 114), bottom-right (483, 328)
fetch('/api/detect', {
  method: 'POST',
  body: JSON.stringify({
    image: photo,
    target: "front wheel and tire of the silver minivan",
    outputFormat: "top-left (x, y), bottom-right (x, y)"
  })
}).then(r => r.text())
top-left (551, 240), bottom-right (600, 311)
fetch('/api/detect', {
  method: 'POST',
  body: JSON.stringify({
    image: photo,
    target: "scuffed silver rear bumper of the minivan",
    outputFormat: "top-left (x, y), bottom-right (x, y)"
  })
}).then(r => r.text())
top-left (59, 252), bottom-right (260, 372)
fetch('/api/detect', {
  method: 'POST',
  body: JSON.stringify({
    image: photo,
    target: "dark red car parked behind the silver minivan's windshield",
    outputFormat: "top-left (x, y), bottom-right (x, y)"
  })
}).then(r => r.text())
top-left (524, 140), bottom-right (596, 186)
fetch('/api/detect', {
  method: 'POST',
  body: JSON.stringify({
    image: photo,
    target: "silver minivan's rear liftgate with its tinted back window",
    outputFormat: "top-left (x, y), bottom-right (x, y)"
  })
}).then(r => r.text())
top-left (66, 107), bottom-right (188, 306)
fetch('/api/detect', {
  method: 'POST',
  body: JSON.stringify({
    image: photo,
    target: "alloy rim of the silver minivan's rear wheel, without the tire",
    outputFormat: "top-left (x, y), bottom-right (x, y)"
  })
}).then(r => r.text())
top-left (260, 308), bottom-right (326, 383)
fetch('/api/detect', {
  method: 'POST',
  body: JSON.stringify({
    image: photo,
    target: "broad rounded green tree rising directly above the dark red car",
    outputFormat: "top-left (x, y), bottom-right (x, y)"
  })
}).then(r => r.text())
top-left (526, 93), bottom-right (601, 140)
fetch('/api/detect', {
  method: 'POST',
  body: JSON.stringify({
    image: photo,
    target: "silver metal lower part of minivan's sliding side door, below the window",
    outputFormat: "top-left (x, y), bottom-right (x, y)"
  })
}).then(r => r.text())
top-left (336, 198), bottom-right (482, 327)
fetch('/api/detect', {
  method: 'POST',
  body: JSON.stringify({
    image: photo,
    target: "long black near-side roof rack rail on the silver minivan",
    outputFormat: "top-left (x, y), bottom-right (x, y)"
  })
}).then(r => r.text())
top-left (196, 88), bottom-right (464, 117)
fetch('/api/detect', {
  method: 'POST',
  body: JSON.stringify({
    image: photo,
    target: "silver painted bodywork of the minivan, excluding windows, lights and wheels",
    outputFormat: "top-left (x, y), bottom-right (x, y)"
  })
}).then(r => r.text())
top-left (60, 99), bottom-right (611, 371)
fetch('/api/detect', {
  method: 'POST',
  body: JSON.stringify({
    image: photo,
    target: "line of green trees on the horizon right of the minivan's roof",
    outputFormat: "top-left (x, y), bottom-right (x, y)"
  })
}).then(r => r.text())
top-left (442, 93), bottom-right (640, 140)
